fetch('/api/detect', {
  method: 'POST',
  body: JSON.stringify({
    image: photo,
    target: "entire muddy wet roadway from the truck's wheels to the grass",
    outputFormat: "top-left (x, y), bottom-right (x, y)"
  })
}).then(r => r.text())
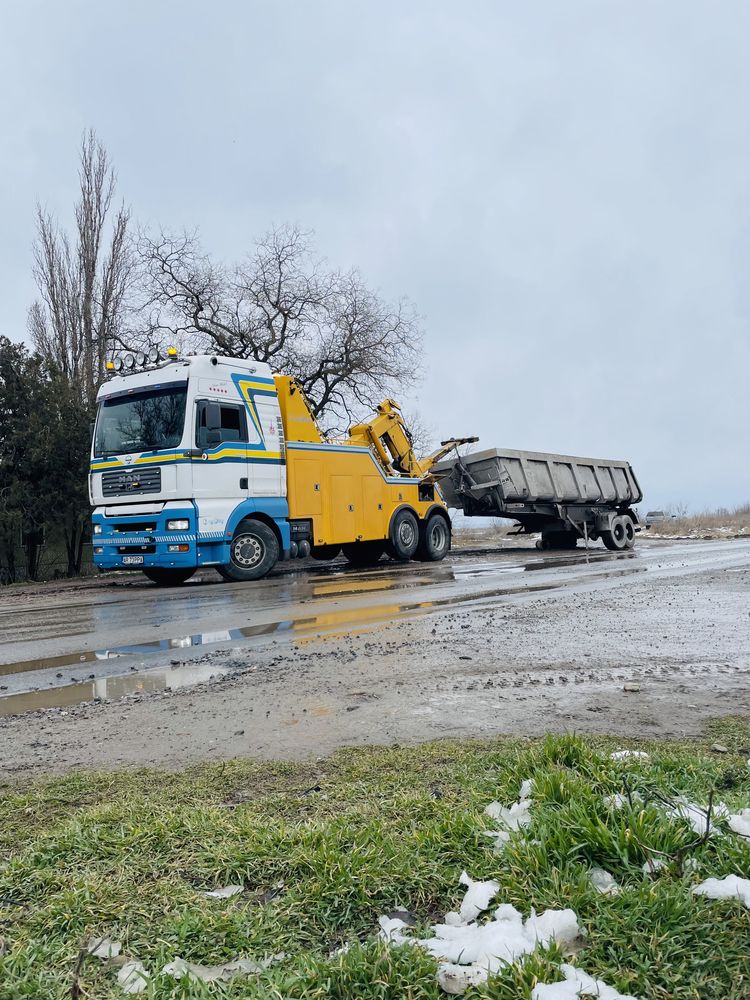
top-left (0, 540), bottom-right (750, 774)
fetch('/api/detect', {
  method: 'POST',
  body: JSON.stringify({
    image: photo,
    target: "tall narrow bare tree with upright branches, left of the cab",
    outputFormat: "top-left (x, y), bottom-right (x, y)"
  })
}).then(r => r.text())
top-left (29, 130), bottom-right (133, 404)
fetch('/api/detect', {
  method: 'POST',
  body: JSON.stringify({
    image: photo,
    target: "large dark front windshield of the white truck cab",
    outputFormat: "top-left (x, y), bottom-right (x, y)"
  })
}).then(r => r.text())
top-left (94, 382), bottom-right (187, 458)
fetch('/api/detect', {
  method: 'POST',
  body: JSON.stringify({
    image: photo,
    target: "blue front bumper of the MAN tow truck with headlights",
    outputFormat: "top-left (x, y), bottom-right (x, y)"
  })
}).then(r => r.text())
top-left (91, 502), bottom-right (199, 570)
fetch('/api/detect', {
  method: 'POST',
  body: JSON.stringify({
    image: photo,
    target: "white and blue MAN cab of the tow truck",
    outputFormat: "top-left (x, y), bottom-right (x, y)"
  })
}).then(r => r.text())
top-left (89, 355), bottom-right (290, 583)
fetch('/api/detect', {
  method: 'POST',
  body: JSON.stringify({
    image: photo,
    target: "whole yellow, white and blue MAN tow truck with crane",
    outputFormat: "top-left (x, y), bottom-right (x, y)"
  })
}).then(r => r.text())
top-left (89, 348), bottom-right (477, 586)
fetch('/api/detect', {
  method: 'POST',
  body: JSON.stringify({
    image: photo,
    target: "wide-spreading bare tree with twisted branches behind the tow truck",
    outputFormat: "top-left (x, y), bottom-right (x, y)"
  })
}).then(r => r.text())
top-left (140, 226), bottom-right (422, 429)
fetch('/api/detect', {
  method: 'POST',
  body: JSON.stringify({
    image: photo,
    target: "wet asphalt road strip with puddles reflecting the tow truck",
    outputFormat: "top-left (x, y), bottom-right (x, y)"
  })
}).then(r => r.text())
top-left (0, 540), bottom-right (750, 715)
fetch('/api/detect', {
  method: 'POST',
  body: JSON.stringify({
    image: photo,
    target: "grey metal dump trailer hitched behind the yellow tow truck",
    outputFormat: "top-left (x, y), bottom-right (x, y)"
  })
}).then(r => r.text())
top-left (431, 448), bottom-right (643, 551)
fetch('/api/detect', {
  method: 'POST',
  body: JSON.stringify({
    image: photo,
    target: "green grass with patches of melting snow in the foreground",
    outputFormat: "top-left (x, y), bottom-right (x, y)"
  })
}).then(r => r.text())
top-left (0, 720), bottom-right (750, 1000)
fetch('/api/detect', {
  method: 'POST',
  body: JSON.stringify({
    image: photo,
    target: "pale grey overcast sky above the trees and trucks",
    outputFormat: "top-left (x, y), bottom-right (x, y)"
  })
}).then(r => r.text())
top-left (0, 0), bottom-right (750, 508)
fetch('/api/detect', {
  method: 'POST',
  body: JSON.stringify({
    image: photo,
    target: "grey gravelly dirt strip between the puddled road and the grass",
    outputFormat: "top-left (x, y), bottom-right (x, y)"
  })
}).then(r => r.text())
top-left (0, 541), bottom-right (750, 777)
